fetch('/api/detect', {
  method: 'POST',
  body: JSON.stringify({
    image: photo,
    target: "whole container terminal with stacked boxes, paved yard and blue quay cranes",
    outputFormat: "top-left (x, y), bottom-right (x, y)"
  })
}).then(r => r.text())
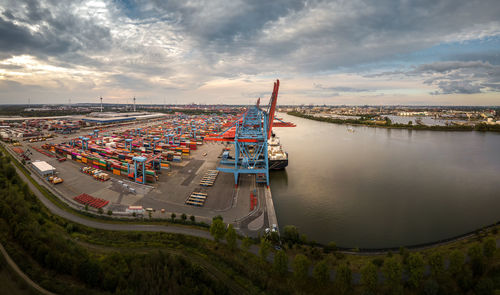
top-left (2, 80), bottom-right (295, 236)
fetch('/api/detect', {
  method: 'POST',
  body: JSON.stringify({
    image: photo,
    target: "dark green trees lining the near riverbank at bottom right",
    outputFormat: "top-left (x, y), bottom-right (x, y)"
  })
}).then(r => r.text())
top-left (274, 226), bottom-right (500, 294)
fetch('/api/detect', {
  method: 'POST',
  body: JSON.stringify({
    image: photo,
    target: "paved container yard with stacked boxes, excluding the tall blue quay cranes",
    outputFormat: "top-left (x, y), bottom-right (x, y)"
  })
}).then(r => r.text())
top-left (1, 110), bottom-right (276, 235)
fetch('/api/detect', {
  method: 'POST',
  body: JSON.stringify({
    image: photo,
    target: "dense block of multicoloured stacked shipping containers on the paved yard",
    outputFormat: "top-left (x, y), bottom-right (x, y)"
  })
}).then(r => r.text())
top-left (42, 116), bottom-right (232, 183)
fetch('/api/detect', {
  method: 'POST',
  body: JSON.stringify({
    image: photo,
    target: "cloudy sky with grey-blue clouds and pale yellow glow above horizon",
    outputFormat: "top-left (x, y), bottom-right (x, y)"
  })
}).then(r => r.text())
top-left (0, 0), bottom-right (500, 105)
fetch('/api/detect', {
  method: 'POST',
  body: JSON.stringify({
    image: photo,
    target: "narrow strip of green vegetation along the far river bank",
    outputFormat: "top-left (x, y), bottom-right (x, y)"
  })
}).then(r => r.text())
top-left (287, 111), bottom-right (500, 132)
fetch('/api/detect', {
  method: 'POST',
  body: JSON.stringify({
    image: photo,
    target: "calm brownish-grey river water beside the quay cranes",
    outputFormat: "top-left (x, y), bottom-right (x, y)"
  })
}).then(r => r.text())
top-left (271, 114), bottom-right (500, 248)
